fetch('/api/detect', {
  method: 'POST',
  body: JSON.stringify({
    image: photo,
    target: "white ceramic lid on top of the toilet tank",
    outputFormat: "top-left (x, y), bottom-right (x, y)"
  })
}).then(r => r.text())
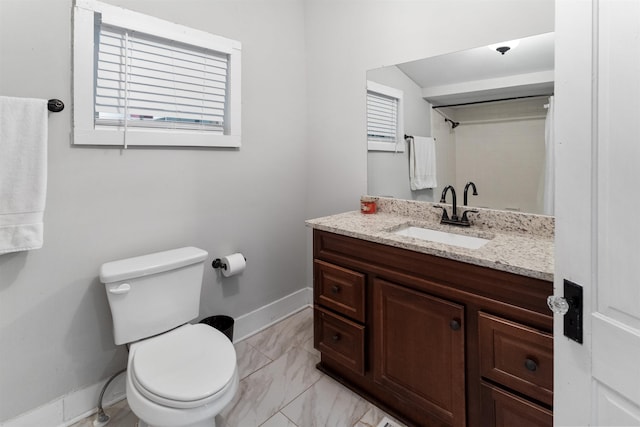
top-left (100, 246), bottom-right (208, 283)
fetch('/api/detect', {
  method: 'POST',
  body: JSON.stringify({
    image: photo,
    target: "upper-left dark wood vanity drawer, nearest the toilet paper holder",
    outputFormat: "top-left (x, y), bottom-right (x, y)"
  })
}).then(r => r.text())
top-left (313, 260), bottom-right (365, 323)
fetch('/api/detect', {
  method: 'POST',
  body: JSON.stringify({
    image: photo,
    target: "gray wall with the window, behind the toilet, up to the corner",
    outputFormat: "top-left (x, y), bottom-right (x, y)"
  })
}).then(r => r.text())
top-left (0, 0), bottom-right (308, 421)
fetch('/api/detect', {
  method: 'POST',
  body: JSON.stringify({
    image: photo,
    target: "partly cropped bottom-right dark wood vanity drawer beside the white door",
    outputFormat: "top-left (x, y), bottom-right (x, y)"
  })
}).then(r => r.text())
top-left (480, 383), bottom-right (553, 427)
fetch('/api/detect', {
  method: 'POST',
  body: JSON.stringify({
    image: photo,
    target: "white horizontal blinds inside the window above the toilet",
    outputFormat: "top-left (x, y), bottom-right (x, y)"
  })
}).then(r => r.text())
top-left (94, 24), bottom-right (229, 134)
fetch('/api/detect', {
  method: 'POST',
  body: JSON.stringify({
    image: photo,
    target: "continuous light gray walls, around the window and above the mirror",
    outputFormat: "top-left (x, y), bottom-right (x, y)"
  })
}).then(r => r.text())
top-left (0, 0), bottom-right (554, 420)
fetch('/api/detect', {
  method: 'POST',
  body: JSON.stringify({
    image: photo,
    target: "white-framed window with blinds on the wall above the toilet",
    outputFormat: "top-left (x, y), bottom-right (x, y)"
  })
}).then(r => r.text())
top-left (74, 0), bottom-right (241, 147)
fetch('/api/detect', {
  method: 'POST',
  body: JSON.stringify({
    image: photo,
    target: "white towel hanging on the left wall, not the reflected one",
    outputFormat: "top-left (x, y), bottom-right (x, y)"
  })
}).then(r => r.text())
top-left (0, 96), bottom-right (47, 254)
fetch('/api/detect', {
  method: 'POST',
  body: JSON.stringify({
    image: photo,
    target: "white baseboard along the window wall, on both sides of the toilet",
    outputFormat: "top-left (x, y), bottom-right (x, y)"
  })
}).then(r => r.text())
top-left (0, 287), bottom-right (313, 427)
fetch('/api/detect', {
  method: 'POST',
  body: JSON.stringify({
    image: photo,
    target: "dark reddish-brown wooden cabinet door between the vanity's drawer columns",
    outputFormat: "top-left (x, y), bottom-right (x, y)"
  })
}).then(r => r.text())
top-left (372, 279), bottom-right (465, 426)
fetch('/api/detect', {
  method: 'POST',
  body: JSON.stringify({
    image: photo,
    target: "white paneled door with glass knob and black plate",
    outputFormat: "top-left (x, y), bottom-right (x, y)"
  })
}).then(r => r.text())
top-left (554, 0), bottom-right (640, 426)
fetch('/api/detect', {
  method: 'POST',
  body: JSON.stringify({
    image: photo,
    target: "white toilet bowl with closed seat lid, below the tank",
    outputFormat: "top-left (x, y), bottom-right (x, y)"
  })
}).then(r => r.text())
top-left (126, 324), bottom-right (238, 427)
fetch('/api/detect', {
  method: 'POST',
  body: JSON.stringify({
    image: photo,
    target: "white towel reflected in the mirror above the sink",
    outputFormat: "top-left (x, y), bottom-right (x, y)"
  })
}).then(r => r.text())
top-left (409, 136), bottom-right (438, 190)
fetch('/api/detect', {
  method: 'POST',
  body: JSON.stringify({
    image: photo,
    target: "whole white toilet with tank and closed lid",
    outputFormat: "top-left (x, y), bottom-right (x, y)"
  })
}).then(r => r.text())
top-left (100, 247), bottom-right (238, 427)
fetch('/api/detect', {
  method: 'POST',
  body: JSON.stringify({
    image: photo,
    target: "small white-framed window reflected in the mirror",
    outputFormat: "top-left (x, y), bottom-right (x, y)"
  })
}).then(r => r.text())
top-left (367, 81), bottom-right (404, 152)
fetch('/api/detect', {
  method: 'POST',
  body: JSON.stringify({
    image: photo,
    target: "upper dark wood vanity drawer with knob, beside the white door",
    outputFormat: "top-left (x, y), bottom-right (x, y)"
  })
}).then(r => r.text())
top-left (478, 313), bottom-right (553, 406)
